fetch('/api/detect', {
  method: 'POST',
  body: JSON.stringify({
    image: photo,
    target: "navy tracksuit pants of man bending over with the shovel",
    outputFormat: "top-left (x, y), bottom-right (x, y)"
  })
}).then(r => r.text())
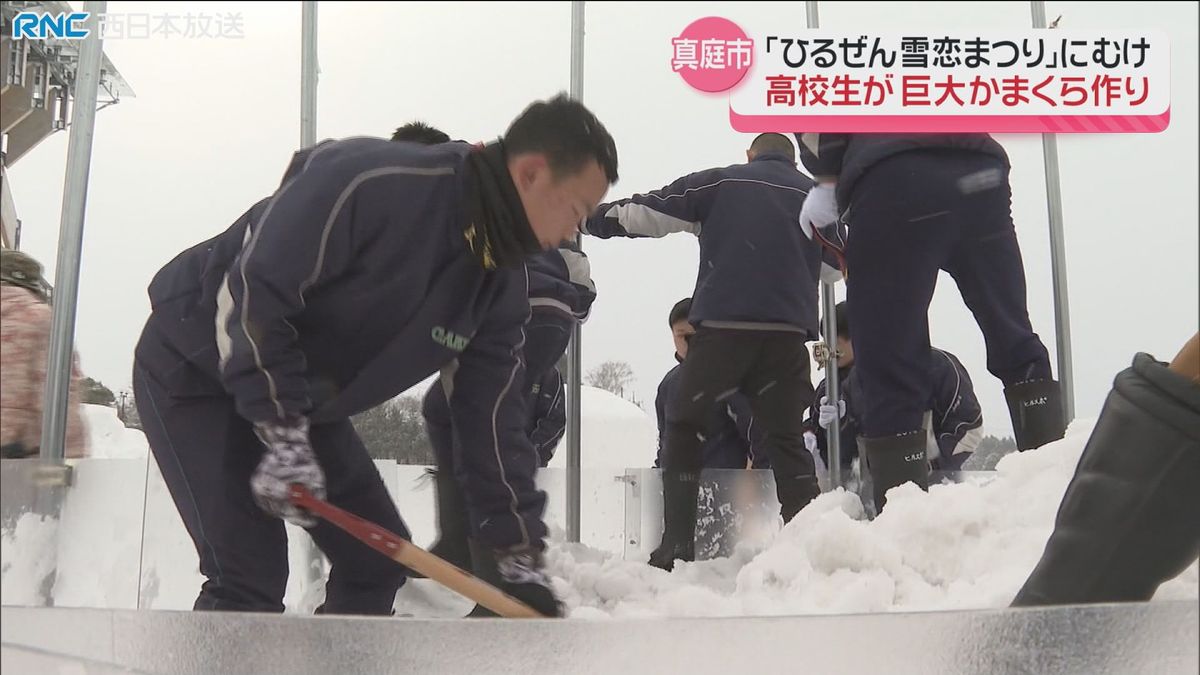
top-left (133, 327), bottom-right (409, 615)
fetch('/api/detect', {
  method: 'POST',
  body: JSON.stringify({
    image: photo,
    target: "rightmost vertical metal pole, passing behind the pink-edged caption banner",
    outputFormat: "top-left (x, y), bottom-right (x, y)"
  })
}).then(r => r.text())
top-left (1030, 0), bottom-right (1075, 424)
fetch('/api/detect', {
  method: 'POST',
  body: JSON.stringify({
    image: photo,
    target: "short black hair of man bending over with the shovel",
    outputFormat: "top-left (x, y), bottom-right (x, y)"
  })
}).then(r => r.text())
top-left (504, 94), bottom-right (617, 184)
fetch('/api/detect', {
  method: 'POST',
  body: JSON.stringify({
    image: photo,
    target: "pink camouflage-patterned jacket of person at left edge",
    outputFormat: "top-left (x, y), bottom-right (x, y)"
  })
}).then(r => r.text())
top-left (0, 250), bottom-right (88, 459)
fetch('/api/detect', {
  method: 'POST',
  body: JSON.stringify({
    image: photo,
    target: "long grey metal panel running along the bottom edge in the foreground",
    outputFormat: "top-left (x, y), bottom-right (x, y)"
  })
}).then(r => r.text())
top-left (0, 602), bottom-right (1200, 675)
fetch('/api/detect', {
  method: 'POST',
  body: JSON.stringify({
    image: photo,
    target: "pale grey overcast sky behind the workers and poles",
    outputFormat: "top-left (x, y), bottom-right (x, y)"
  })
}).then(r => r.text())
top-left (11, 1), bottom-right (1200, 435)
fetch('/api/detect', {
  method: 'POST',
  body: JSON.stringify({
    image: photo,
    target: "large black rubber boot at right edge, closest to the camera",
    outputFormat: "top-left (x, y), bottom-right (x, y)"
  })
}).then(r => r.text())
top-left (1013, 354), bottom-right (1200, 607)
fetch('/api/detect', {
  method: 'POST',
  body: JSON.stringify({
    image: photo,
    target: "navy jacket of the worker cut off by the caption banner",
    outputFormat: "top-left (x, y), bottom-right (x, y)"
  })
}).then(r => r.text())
top-left (796, 132), bottom-right (1009, 213)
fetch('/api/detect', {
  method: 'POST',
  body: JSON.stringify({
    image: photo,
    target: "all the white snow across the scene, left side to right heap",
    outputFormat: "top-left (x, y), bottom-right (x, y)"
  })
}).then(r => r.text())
top-left (0, 393), bottom-right (1200, 620)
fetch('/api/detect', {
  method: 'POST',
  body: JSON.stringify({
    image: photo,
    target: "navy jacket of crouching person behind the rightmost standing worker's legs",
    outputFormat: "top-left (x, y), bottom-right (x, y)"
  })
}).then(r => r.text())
top-left (809, 348), bottom-right (983, 468)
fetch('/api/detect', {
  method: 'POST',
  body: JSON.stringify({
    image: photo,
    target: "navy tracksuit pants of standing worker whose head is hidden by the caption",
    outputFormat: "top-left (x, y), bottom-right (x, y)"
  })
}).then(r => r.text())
top-left (846, 150), bottom-right (1051, 437)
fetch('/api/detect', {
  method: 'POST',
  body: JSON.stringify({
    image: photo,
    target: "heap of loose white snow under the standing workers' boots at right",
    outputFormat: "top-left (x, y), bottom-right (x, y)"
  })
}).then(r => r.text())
top-left (548, 422), bottom-right (1200, 619)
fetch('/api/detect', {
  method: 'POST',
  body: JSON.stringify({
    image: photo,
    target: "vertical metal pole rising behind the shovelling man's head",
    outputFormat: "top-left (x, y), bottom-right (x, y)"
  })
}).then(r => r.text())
top-left (566, 0), bottom-right (583, 542)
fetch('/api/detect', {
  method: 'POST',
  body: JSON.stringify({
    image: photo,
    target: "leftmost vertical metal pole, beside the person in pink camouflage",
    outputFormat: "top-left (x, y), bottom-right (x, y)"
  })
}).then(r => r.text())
top-left (41, 1), bottom-right (108, 468)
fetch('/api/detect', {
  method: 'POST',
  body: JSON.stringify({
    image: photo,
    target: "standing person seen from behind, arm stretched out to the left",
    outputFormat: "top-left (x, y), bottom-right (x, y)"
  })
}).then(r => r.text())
top-left (583, 133), bottom-right (836, 569)
